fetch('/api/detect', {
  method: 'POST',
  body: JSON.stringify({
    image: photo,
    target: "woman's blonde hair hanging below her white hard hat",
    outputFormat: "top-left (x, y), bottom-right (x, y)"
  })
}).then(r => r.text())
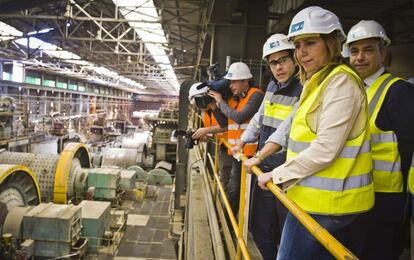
top-left (295, 31), bottom-right (346, 84)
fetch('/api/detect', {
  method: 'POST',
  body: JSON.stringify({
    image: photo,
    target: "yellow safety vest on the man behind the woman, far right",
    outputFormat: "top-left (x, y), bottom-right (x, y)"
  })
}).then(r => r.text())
top-left (367, 73), bottom-right (403, 192)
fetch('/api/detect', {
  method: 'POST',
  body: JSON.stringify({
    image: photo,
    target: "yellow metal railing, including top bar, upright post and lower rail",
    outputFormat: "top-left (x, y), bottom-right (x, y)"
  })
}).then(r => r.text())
top-left (220, 139), bottom-right (358, 260)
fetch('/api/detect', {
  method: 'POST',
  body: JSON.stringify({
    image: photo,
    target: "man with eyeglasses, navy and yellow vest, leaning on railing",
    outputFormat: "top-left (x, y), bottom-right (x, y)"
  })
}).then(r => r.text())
top-left (232, 34), bottom-right (302, 260)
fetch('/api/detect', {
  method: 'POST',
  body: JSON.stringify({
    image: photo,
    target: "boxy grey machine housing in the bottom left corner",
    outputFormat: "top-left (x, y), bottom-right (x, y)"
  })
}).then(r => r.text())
top-left (1, 203), bottom-right (87, 259)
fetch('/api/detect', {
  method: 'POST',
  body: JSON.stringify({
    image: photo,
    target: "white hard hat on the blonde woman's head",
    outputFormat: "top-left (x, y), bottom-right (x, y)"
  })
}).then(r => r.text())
top-left (288, 6), bottom-right (346, 40)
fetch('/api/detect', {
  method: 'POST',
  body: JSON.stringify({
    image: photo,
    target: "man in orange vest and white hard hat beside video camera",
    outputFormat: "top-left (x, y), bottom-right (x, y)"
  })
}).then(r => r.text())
top-left (209, 62), bottom-right (263, 214)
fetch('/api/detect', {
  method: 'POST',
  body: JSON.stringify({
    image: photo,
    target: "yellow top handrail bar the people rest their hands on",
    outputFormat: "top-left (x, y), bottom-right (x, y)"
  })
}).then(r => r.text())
top-left (218, 139), bottom-right (358, 260)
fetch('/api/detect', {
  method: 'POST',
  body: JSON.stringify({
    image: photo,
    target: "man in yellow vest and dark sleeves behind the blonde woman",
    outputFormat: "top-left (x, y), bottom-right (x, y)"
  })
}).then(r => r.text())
top-left (346, 20), bottom-right (414, 259)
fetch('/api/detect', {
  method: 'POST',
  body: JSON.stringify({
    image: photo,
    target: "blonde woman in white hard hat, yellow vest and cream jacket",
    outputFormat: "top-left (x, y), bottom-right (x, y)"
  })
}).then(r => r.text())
top-left (259, 6), bottom-right (374, 260)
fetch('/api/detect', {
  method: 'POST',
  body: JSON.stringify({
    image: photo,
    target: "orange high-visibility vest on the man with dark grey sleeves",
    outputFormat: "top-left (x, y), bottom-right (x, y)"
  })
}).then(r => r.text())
top-left (227, 88), bottom-right (262, 156)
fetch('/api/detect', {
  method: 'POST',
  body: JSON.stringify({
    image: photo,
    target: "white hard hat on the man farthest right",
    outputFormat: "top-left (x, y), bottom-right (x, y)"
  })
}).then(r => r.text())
top-left (346, 20), bottom-right (391, 46)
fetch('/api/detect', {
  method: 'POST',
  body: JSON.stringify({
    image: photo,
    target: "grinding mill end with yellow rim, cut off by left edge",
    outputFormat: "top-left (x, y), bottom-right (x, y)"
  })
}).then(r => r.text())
top-left (0, 167), bottom-right (40, 230)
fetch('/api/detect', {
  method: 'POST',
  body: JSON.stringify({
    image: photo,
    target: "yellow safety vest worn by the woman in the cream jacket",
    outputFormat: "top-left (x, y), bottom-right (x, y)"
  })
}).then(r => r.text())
top-left (287, 65), bottom-right (374, 215)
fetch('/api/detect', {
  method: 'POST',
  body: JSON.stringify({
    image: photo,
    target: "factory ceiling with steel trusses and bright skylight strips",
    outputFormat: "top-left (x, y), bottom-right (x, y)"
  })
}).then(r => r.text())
top-left (0, 0), bottom-right (414, 95)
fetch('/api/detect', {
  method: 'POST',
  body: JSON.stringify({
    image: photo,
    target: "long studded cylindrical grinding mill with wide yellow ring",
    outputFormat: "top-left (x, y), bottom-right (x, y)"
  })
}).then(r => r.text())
top-left (0, 143), bottom-right (91, 204)
